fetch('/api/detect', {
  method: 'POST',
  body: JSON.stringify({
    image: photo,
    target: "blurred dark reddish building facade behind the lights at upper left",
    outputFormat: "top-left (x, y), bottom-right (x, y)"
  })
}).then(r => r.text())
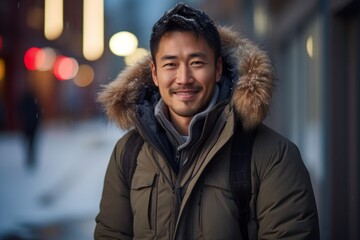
top-left (0, 0), bottom-right (98, 130)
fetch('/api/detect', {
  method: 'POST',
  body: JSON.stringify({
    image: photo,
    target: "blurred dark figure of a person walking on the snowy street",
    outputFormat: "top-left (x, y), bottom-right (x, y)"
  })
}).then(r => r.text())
top-left (19, 89), bottom-right (41, 169)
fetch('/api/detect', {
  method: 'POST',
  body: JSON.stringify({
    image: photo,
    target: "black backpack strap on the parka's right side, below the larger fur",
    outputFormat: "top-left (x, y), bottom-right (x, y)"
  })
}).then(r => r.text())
top-left (230, 126), bottom-right (257, 240)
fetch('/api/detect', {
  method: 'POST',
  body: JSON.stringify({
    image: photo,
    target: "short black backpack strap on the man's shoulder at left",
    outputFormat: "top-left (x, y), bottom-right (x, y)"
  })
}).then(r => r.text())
top-left (121, 131), bottom-right (144, 189)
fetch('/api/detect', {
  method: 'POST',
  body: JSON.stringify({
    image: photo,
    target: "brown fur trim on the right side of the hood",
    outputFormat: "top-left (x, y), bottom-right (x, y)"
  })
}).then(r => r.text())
top-left (218, 27), bottom-right (274, 129)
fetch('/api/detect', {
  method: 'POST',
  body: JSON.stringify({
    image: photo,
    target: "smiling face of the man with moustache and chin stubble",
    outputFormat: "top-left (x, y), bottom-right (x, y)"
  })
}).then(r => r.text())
top-left (151, 31), bottom-right (222, 120)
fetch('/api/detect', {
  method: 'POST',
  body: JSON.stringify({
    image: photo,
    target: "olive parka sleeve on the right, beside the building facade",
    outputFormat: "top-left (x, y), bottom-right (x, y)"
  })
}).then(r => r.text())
top-left (256, 133), bottom-right (320, 239)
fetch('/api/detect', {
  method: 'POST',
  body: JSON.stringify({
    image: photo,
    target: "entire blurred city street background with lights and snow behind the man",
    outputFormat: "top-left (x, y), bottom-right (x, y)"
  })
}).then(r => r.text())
top-left (0, 0), bottom-right (360, 240)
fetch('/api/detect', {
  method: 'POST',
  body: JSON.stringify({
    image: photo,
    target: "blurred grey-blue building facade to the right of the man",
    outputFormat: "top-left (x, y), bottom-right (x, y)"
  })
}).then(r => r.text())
top-left (202, 0), bottom-right (360, 240)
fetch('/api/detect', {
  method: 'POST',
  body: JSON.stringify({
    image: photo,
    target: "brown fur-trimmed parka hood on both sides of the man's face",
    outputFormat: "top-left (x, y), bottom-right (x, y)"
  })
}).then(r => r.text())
top-left (98, 27), bottom-right (274, 129)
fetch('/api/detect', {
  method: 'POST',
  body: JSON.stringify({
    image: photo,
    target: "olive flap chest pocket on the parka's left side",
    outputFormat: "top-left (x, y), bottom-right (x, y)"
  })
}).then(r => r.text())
top-left (130, 170), bottom-right (158, 239)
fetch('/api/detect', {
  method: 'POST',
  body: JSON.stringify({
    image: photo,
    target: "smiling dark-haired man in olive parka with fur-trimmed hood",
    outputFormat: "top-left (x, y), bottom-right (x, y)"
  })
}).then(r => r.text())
top-left (95, 4), bottom-right (319, 239)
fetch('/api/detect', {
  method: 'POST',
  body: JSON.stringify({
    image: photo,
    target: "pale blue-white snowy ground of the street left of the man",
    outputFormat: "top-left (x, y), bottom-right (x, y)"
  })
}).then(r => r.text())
top-left (0, 119), bottom-right (122, 240)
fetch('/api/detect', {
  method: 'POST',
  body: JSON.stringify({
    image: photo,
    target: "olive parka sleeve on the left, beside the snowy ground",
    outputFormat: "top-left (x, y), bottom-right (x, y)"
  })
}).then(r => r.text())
top-left (94, 136), bottom-right (133, 240)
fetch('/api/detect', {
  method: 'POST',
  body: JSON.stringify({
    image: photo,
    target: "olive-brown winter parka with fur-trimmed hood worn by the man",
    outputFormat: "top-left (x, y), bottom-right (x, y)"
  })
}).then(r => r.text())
top-left (95, 27), bottom-right (319, 239)
